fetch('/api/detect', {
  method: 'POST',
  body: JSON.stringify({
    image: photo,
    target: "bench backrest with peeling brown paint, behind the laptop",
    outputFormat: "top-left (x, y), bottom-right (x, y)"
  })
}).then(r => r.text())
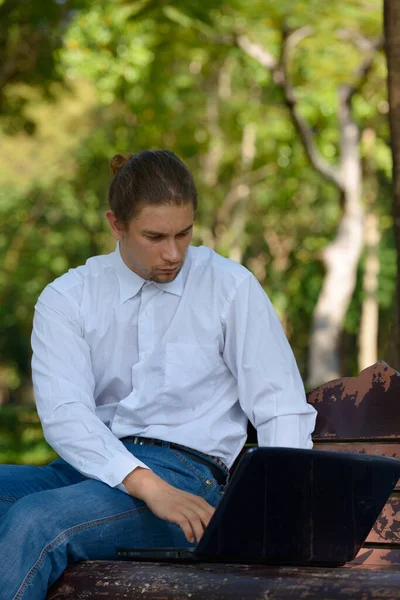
top-left (308, 362), bottom-right (400, 568)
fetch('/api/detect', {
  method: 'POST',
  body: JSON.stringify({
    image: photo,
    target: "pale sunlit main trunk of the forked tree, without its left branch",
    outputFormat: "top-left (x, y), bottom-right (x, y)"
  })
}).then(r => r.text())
top-left (308, 86), bottom-right (363, 387)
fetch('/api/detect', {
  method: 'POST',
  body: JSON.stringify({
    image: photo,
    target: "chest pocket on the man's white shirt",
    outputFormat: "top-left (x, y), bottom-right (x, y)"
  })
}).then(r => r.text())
top-left (164, 343), bottom-right (221, 406)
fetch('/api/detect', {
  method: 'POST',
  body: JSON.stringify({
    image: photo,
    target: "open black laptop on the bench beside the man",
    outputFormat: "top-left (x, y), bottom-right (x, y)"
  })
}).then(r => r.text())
top-left (117, 448), bottom-right (400, 566)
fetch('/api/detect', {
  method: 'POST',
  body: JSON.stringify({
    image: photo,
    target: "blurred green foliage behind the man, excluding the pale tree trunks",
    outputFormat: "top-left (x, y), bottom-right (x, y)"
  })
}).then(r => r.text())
top-left (0, 0), bottom-right (396, 460)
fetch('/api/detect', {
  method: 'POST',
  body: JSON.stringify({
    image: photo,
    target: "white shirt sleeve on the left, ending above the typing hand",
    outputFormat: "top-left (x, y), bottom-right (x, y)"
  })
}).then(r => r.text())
top-left (31, 286), bottom-right (148, 491)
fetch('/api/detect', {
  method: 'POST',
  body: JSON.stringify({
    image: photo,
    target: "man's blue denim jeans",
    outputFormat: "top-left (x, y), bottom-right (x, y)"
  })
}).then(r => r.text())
top-left (0, 442), bottom-right (222, 600)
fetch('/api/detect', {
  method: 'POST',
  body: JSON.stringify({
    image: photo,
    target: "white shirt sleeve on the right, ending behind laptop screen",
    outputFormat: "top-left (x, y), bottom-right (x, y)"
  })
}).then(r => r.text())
top-left (224, 274), bottom-right (316, 448)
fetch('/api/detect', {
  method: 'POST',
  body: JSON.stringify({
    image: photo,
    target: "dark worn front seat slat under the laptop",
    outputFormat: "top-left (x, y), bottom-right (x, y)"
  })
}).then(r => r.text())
top-left (48, 561), bottom-right (400, 600)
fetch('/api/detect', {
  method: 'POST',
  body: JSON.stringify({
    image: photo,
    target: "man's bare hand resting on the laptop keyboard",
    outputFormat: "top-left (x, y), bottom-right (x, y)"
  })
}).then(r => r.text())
top-left (122, 467), bottom-right (215, 543)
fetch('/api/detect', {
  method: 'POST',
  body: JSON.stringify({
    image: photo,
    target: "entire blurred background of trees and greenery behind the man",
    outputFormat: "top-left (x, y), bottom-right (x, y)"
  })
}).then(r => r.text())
top-left (0, 0), bottom-right (398, 464)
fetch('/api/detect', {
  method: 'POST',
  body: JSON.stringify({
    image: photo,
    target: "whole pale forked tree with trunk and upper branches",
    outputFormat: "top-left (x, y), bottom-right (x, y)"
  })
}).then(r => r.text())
top-left (228, 8), bottom-right (383, 386)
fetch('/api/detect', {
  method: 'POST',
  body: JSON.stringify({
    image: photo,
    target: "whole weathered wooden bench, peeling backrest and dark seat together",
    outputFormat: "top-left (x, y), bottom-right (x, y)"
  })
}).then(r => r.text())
top-left (48, 362), bottom-right (400, 600)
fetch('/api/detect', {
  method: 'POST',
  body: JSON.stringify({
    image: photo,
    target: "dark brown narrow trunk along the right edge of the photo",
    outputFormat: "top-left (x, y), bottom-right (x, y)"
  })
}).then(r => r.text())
top-left (384, 0), bottom-right (400, 369)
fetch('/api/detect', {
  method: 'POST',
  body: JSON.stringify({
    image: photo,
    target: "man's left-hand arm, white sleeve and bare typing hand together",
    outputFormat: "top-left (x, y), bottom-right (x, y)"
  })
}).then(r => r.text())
top-left (32, 286), bottom-right (214, 542)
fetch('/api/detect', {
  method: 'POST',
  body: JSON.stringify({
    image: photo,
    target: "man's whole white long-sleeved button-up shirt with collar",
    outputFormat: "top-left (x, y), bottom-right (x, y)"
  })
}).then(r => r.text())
top-left (32, 245), bottom-right (316, 489)
